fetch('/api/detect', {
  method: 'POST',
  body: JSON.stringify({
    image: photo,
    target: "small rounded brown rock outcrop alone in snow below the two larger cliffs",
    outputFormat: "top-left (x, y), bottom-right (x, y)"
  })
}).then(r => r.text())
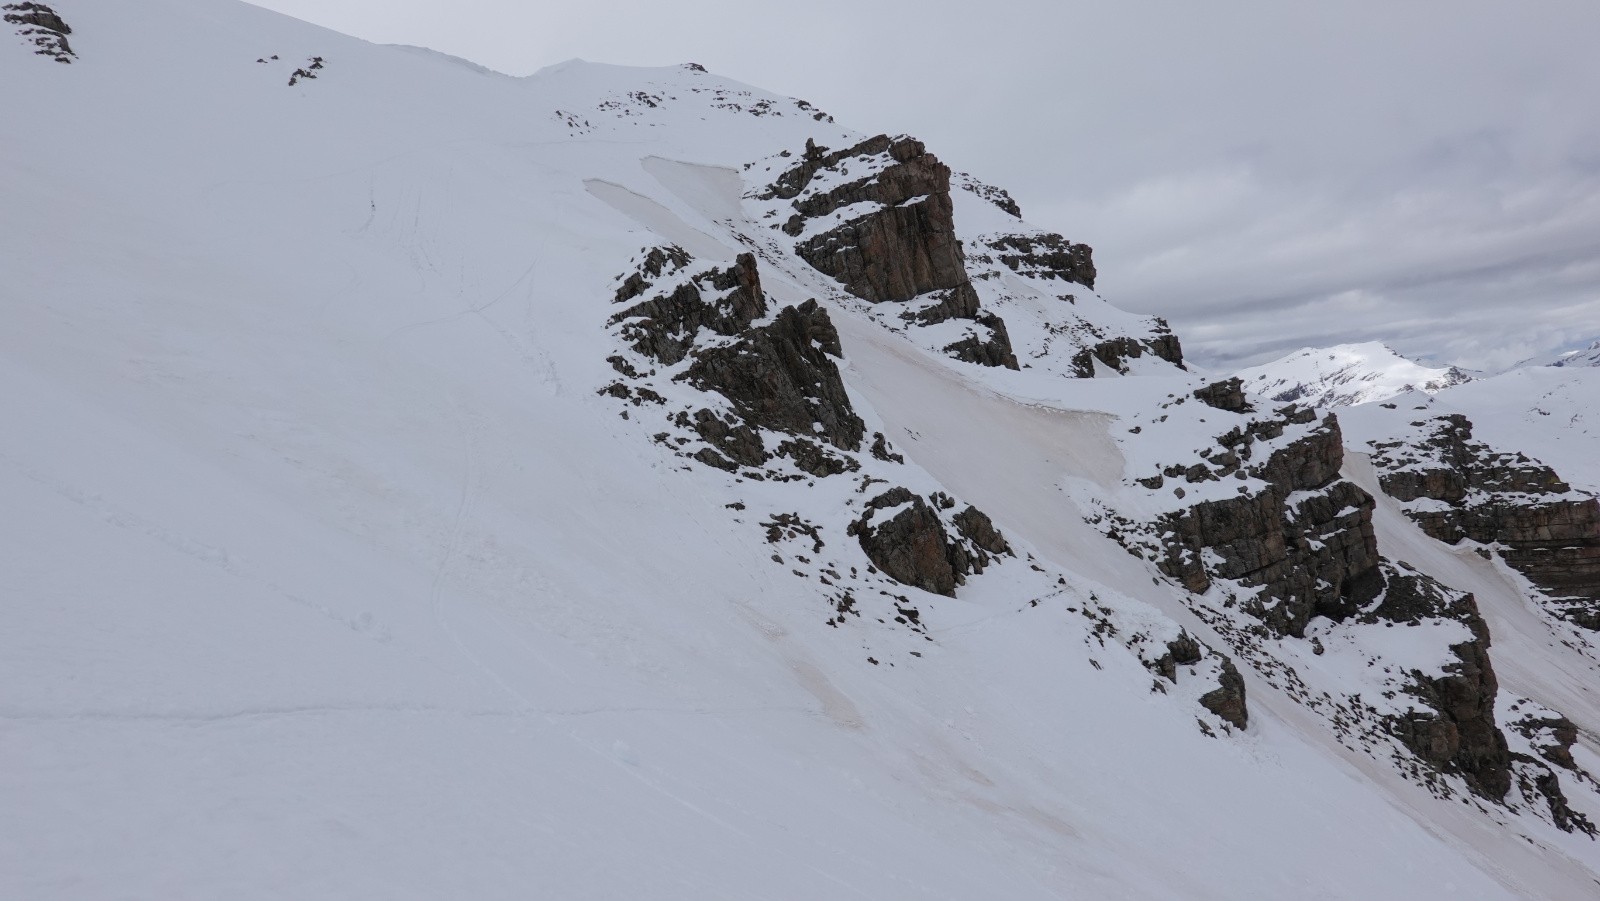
top-left (848, 488), bottom-right (1011, 597)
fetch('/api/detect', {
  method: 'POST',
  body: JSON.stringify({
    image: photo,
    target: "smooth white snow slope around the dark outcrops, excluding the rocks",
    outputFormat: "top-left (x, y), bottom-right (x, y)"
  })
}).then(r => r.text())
top-left (0, 0), bottom-right (1600, 898)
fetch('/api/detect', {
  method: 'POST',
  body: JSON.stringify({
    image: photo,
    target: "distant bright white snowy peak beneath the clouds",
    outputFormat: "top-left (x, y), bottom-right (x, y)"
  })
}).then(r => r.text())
top-left (1237, 341), bottom-right (1472, 406)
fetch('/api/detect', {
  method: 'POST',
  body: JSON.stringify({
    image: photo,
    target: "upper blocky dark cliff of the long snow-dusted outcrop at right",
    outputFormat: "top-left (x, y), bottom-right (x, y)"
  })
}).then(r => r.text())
top-left (1144, 408), bottom-right (1382, 637)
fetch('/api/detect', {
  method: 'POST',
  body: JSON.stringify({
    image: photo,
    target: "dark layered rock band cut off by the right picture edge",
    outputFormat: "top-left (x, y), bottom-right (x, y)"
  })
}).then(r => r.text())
top-left (1373, 414), bottom-right (1600, 629)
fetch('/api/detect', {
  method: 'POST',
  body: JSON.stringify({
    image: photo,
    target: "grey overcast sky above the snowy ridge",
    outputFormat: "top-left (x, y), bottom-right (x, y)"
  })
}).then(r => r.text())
top-left (258, 0), bottom-right (1600, 368)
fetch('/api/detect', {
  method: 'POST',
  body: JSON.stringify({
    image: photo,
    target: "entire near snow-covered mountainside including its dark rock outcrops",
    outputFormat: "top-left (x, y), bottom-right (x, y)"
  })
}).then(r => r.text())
top-left (9, 0), bottom-right (1600, 899)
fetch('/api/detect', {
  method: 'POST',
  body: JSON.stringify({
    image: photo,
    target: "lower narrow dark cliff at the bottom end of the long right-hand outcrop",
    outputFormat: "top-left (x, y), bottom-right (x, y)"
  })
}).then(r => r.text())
top-left (1363, 565), bottom-right (1512, 800)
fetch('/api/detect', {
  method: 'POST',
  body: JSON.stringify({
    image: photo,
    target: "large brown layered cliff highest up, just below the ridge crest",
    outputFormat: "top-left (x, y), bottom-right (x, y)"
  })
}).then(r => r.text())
top-left (757, 134), bottom-right (1018, 370)
